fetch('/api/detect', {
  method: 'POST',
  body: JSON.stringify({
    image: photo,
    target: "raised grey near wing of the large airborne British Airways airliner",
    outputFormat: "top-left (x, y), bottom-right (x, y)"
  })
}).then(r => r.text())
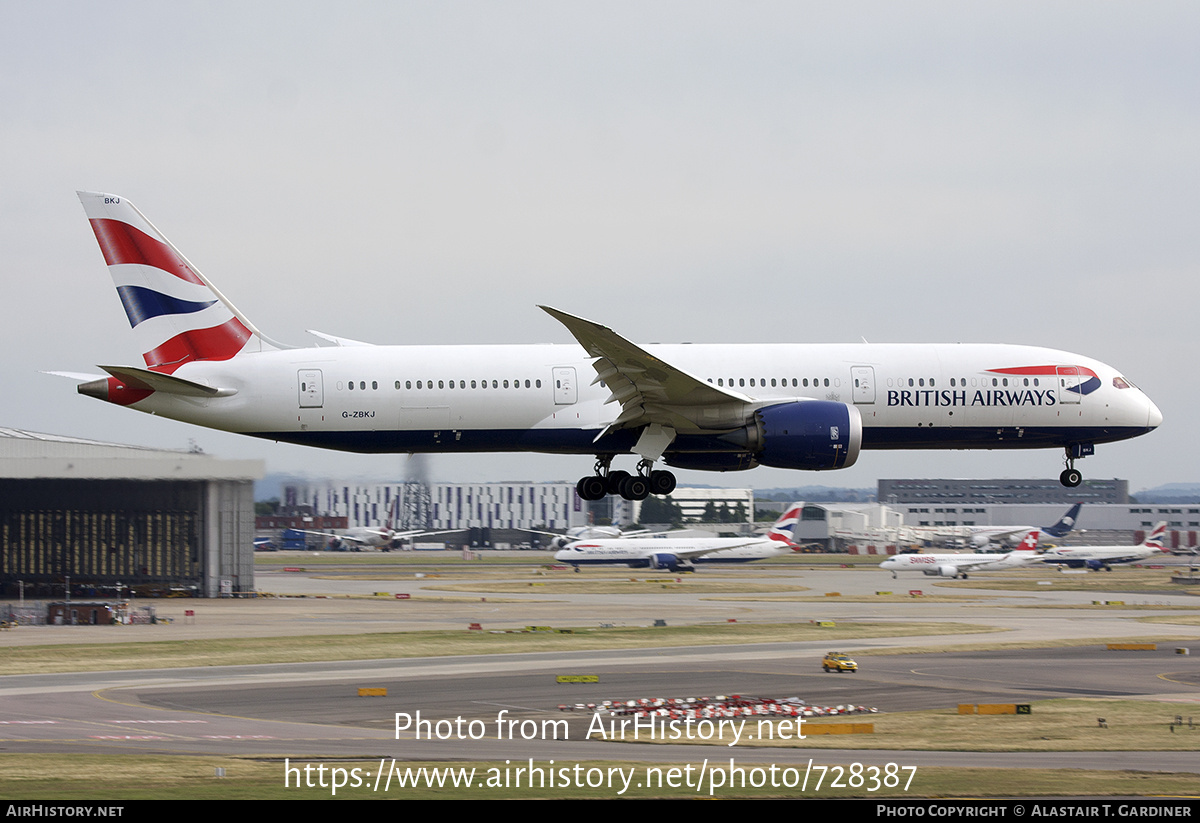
top-left (540, 306), bottom-right (754, 447)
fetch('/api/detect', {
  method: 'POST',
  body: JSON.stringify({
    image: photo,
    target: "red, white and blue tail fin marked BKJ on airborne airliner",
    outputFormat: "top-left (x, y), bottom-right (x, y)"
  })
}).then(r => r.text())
top-left (78, 192), bottom-right (280, 374)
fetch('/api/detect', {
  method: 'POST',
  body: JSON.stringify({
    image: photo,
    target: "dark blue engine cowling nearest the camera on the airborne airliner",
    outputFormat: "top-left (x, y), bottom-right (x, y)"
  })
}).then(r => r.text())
top-left (755, 400), bottom-right (863, 471)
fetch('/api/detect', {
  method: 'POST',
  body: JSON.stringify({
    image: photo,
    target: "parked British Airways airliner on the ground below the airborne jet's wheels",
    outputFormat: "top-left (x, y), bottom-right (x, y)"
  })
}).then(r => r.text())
top-left (554, 503), bottom-right (804, 571)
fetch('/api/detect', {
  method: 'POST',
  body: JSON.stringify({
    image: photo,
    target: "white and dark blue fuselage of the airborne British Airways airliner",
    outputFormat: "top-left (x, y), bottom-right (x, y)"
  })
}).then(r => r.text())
top-left (98, 344), bottom-right (1160, 455)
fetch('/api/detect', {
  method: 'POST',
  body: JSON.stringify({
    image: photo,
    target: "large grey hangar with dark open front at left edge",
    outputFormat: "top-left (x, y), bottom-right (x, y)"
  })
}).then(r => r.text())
top-left (0, 428), bottom-right (265, 597)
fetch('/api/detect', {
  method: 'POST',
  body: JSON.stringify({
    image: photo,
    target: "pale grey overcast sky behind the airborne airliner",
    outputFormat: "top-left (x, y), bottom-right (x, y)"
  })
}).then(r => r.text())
top-left (0, 0), bottom-right (1200, 489)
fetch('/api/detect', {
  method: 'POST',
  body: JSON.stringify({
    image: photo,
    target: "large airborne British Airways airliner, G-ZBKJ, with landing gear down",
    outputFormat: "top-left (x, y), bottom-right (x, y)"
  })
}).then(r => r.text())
top-left (67, 192), bottom-right (1162, 500)
